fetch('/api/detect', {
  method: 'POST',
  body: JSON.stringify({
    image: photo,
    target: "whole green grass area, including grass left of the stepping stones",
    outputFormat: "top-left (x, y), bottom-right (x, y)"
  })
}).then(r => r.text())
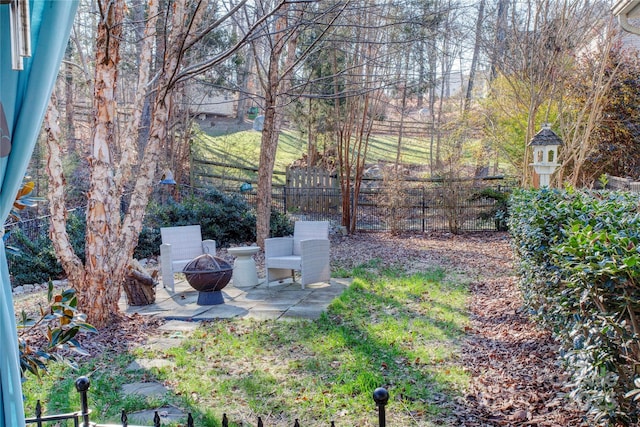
top-left (24, 260), bottom-right (469, 426)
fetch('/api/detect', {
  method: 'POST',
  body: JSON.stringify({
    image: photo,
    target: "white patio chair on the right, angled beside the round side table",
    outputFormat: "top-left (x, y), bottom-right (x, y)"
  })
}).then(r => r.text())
top-left (264, 221), bottom-right (331, 289)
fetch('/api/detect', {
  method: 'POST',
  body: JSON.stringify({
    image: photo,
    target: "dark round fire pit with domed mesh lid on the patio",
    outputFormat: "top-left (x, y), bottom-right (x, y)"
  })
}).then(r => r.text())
top-left (182, 254), bottom-right (233, 305)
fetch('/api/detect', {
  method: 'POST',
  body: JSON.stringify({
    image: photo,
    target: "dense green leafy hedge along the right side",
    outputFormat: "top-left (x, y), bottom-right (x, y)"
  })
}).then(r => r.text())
top-left (509, 189), bottom-right (640, 425)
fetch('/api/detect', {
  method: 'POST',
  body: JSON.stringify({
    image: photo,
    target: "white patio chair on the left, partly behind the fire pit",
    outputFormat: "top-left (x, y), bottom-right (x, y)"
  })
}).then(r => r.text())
top-left (160, 225), bottom-right (216, 292)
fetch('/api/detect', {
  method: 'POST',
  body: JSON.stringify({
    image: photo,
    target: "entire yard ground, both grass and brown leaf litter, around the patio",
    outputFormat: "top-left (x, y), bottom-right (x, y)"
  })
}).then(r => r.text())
top-left (16, 233), bottom-right (587, 426)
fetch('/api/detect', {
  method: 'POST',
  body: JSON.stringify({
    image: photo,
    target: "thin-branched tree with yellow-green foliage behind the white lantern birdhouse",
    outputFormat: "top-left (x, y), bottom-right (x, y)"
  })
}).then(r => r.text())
top-left (483, 0), bottom-right (608, 185)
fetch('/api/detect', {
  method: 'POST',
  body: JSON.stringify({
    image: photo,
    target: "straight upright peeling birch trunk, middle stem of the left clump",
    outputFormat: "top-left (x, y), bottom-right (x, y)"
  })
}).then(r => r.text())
top-left (80, 0), bottom-right (126, 327)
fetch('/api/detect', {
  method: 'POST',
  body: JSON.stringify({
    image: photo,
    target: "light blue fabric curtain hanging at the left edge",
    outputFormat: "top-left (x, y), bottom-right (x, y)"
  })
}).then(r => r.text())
top-left (0, 0), bottom-right (78, 427)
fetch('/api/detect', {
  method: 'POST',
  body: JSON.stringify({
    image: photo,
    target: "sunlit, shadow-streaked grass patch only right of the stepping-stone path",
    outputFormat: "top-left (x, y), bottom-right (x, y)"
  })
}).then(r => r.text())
top-left (151, 275), bottom-right (466, 425)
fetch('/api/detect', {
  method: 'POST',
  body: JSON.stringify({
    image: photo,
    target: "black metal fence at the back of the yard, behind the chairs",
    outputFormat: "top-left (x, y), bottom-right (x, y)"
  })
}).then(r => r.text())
top-left (238, 182), bottom-right (511, 233)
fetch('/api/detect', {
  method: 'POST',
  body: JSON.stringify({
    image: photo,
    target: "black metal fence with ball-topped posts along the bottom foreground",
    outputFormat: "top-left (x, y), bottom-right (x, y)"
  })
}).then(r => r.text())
top-left (25, 377), bottom-right (389, 427)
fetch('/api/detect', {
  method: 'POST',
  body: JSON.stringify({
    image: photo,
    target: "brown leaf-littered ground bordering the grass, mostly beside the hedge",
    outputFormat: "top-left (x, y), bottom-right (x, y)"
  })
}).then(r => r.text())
top-left (16, 233), bottom-right (590, 427)
